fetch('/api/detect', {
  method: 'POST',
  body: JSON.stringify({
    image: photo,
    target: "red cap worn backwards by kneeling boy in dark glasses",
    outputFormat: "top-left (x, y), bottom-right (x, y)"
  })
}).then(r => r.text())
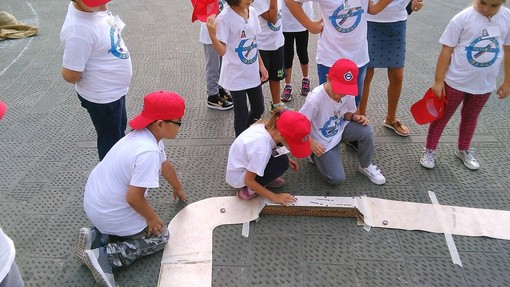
top-left (129, 91), bottom-right (185, 130)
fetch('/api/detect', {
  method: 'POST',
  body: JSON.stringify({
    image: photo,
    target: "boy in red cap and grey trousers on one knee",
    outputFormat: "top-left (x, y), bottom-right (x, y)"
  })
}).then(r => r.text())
top-left (300, 59), bottom-right (386, 185)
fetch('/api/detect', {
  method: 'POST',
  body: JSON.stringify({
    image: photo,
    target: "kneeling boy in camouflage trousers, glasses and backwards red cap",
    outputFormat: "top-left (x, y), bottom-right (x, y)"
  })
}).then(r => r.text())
top-left (76, 91), bottom-right (186, 286)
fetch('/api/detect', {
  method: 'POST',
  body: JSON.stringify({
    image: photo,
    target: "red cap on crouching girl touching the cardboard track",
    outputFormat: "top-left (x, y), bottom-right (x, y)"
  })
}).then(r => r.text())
top-left (276, 111), bottom-right (312, 158)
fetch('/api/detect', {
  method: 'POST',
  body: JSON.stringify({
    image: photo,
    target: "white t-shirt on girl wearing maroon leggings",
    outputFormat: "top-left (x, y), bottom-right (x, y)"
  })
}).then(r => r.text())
top-left (439, 7), bottom-right (510, 94)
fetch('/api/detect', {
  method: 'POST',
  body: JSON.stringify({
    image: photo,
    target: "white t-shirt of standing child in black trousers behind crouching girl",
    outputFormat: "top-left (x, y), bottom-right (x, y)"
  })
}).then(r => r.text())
top-left (216, 6), bottom-right (260, 91)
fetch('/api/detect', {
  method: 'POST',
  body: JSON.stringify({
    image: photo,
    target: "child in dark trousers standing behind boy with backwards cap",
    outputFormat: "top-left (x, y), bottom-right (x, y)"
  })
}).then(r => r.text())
top-left (60, 0), bottom-right (132, 160)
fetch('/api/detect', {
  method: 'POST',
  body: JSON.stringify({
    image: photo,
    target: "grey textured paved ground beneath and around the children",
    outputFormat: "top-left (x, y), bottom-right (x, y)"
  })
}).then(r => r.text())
top-left (0, 0), bottom-right (510, 286)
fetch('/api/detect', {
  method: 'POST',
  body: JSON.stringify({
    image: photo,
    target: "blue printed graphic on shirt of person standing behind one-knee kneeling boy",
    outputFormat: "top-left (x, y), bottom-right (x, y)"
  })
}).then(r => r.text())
top-left (328, 1), bottom-right (365, 33)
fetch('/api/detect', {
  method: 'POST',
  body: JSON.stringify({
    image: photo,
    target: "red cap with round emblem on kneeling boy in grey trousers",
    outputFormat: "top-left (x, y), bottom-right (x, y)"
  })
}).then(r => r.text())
top-left (328, 59), bottom-right (359, 96)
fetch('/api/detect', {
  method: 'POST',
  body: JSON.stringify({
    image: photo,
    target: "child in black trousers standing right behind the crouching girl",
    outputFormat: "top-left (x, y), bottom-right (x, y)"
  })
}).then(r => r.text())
top-left (207, 0), bottom-right (268, 137)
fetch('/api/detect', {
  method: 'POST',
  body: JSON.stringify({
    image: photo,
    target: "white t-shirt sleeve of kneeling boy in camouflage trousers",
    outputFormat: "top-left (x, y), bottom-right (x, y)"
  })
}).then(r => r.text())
top-left (129, 151), bottom-right (161, 188)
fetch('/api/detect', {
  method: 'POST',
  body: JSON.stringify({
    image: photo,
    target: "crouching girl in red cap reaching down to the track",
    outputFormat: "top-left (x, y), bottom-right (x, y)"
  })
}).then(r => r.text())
top-left (226, 107), bottom-right (311, 205)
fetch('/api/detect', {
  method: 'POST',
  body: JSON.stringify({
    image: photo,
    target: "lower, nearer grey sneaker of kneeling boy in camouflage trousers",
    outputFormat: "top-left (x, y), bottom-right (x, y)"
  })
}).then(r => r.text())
top-left (84, 247), bottom-right (119, 287)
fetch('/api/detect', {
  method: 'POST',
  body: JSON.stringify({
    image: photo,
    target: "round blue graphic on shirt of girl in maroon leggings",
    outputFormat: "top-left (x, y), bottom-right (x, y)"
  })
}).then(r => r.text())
top-left (466, 29), bottom-right (500, 68)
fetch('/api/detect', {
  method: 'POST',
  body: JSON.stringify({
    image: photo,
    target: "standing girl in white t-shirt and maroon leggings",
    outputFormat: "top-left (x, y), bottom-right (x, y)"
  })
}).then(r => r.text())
top-left (420, 0), bottom-right (510, 170)
